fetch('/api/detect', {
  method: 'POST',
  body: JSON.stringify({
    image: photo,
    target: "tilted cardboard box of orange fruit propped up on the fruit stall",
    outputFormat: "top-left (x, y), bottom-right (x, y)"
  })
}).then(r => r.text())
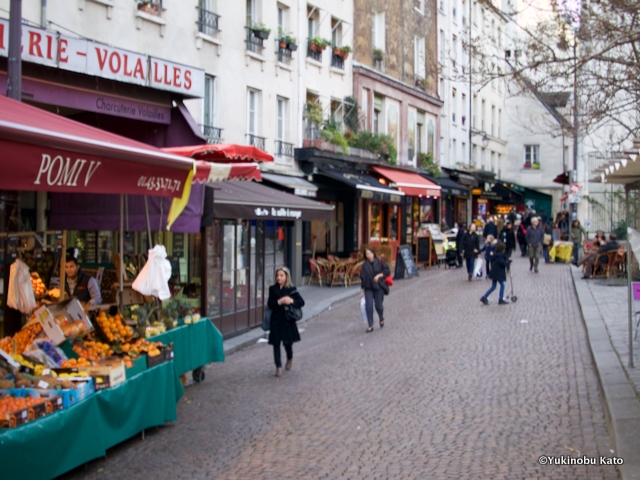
top-left (34, 298), bottom-right (93, 345)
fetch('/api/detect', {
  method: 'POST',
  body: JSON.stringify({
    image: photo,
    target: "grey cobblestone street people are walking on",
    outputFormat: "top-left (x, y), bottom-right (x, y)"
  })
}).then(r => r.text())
top-left (63, 257), bottom-right (618, 480)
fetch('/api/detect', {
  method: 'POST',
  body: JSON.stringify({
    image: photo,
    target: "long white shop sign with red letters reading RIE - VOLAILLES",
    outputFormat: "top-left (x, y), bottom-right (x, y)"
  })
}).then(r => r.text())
top-left (0, 18), bottom-right (204, 98)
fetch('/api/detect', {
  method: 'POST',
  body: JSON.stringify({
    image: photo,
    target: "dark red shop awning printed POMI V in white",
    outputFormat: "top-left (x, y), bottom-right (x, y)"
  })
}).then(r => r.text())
top-left (0, 96), bottom-right (193, 197)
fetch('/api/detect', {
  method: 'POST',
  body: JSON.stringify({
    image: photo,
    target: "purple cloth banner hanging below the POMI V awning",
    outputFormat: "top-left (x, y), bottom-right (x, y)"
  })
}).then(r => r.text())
top-left (49, 183), bottom-right (205, 233)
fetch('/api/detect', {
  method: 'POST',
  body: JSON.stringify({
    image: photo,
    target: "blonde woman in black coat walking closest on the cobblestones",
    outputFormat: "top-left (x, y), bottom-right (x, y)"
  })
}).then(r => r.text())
top-left (267, 267), bottom-right (304, 377)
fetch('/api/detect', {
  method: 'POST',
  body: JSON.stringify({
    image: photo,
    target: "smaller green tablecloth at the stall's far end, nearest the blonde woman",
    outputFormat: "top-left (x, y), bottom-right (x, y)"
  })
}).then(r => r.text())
top-left (149, 318), bottom-right (224, 375)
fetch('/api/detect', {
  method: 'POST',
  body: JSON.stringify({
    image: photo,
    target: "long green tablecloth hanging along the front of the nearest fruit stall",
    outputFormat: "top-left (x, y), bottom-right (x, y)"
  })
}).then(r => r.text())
top-left (0, 361), bottom-right (183, 480)
